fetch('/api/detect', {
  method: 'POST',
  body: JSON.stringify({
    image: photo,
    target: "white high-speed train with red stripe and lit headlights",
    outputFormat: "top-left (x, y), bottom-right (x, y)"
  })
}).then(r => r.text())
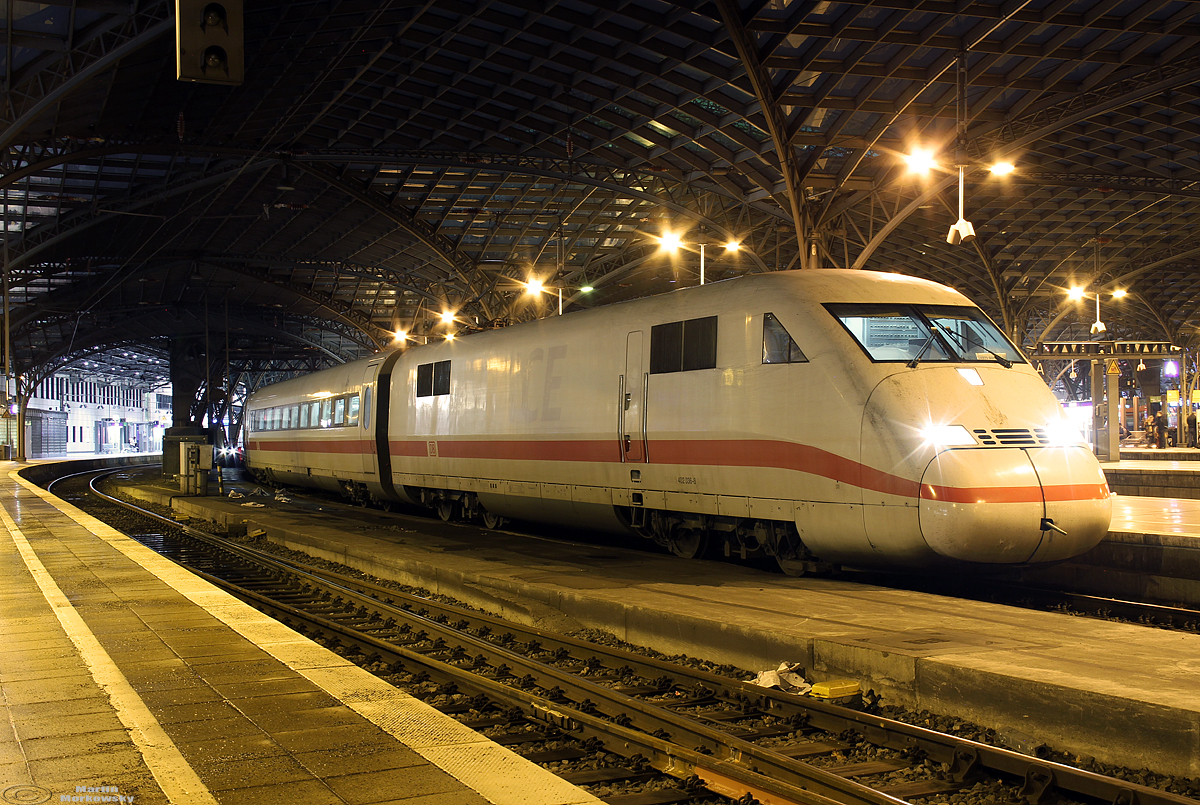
top-left (246, 270), bottom-right (1111, 572)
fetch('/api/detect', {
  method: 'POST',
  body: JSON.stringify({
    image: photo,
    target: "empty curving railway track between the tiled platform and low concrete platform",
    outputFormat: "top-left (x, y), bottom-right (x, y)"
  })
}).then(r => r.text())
top-left (54, 465), bottom-right (1195, 805)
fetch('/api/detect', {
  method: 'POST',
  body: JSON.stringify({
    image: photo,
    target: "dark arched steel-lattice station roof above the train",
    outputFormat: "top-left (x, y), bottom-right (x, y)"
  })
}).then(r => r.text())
top-left (0, 0), bottom-right (1200, 395)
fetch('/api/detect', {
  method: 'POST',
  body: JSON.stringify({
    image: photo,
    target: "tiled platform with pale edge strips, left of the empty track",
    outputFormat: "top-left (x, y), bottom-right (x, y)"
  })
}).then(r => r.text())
top-left (0, 462), bottom-right (600, 805)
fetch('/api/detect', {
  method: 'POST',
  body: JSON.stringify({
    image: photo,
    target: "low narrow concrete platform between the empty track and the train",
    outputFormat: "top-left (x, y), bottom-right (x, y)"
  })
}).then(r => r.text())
top-left (108, 465), bottom-right (1200, 776)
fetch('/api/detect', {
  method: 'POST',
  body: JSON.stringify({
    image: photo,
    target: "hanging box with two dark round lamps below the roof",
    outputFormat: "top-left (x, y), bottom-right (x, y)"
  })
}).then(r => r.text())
top-left (175, 0), bottom-right (245, 85)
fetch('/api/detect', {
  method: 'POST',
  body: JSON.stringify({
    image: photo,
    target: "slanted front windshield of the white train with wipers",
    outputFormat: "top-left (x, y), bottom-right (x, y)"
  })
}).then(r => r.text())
top-left (826, 305), bottom-right (1025, 366)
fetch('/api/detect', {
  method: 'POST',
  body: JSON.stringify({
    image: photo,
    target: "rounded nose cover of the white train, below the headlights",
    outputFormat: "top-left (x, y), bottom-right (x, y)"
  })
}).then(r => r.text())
top-left (919, 445), bottom-right (1112, 564)
